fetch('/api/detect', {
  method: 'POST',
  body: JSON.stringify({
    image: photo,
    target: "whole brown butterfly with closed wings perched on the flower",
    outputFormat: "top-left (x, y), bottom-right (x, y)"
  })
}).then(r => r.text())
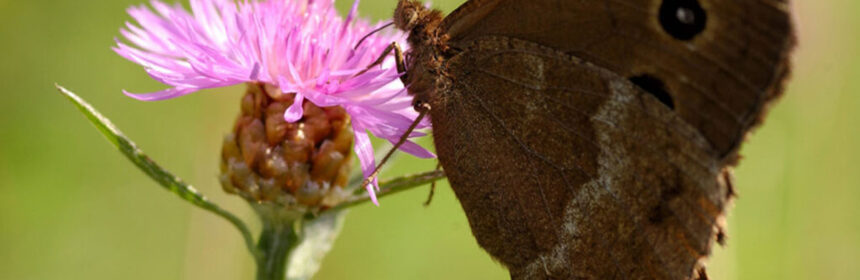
top-left (366, 0), bottom-right (794, 279)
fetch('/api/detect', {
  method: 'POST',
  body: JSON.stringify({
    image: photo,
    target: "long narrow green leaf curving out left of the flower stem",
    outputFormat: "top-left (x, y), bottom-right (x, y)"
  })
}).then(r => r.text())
top-left (55, 85), bottom-right (259, 259)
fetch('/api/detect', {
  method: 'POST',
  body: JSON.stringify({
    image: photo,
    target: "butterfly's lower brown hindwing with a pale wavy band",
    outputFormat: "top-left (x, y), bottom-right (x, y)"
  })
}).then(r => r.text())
top-left (430, 37), bottom-right (729, 279)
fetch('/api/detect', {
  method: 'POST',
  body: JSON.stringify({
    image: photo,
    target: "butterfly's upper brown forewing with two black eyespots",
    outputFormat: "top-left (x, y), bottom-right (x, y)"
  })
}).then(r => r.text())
top-left (442, 0), bottom-right (794, 160)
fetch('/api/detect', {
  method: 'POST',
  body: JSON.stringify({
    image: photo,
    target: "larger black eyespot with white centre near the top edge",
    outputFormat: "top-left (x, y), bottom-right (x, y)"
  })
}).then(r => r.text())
top-left (659, 0), bottom-right (708, 41)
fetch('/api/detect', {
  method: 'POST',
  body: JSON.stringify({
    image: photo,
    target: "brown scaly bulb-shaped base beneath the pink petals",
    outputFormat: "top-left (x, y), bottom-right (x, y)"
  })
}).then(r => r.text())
top-left (225, 83), bottom-right (353, 212)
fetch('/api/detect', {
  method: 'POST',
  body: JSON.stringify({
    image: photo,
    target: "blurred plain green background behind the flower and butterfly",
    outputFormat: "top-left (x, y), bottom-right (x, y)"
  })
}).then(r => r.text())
top-left (0, 0), bottom-right (860, 279)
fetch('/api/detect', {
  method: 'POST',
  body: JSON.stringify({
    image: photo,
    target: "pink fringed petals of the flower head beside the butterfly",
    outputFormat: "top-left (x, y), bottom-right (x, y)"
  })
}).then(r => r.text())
top-left (113, 0), bottom-right (434, 205)
